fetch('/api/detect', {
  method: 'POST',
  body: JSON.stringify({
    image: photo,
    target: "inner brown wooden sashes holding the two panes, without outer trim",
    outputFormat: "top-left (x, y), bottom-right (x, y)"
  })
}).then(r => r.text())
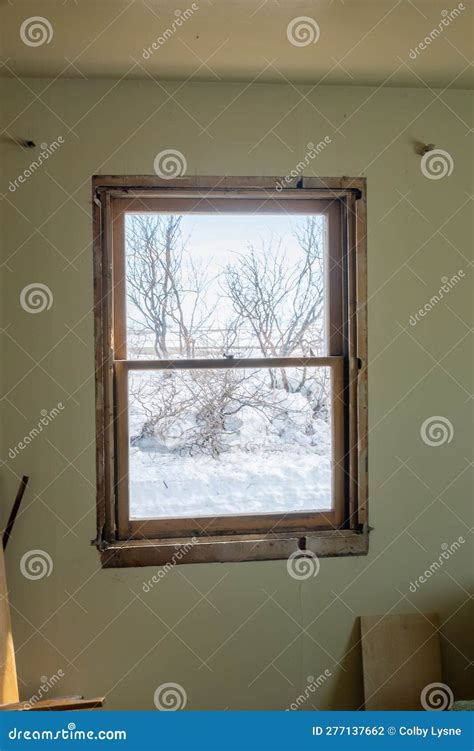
top-left (112, 200), bottom-right (347, 539)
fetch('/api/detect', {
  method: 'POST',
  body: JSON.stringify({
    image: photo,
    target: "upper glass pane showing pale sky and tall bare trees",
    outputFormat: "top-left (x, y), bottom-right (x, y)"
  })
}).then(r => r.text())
top-left (125, 213), bottom-right (327, 359)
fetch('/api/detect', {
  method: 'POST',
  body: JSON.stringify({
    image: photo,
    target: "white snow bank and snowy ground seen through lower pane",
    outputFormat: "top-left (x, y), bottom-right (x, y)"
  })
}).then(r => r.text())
top-left (129, 369), bottom-right (331, 519)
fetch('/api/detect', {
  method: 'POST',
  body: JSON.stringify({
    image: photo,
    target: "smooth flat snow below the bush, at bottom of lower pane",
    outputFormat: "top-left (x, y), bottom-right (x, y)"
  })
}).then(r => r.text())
top-left (130, 448), bottom-right (331, 519)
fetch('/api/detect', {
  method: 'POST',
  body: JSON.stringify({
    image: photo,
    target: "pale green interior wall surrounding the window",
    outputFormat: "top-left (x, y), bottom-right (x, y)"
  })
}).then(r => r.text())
top-left (0, 79), bottom-right (473, 709)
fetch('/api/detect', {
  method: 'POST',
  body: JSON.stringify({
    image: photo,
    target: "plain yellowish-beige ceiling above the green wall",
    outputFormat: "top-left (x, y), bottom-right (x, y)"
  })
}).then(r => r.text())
top-left (0, 0), bottom-right (474, 88)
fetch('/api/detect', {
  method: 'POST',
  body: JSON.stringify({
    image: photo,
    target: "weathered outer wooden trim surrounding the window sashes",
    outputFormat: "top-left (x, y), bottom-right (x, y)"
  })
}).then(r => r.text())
top-left (93, 175), bottom-right (368, 566)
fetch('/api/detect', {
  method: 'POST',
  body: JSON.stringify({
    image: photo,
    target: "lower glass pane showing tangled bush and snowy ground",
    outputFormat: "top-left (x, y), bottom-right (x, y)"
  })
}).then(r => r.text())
top-left (129, 367), bottom-right (332, 519)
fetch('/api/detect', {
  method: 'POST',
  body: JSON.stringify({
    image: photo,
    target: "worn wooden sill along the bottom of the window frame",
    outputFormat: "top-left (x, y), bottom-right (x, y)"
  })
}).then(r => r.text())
top-left (100, 530), bottom-right (369, 568)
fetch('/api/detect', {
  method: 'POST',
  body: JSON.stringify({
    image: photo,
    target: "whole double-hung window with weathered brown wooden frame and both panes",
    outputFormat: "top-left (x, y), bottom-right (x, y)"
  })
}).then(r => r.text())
top-left (94, 177), bottom-right (367, 566)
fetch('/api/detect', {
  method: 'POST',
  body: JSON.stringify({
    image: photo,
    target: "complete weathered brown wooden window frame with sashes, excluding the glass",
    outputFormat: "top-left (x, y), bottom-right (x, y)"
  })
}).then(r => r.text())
top-left (93, 176), bottom-right (368, 567)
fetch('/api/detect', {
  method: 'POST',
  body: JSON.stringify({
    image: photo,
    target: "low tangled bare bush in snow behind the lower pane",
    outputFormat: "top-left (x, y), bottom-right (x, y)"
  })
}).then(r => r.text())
top-left (130, 368), bottom-right (309, 458)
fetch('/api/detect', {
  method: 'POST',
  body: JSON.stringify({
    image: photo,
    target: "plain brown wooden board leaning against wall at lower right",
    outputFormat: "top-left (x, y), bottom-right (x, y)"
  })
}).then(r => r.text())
top-left (360, 613), bottom-right (441, 710)
